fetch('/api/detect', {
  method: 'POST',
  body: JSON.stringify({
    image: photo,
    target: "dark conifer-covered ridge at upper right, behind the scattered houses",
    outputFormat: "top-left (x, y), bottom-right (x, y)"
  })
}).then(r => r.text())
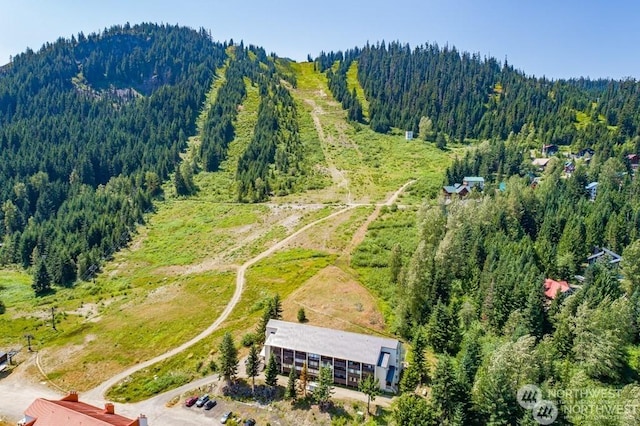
top-left (316, 42), bottom-right (640, 150)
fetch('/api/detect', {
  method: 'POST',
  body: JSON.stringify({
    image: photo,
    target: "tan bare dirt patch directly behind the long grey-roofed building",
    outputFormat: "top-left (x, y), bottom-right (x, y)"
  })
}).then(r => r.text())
top-left (283, 265), bottom-right (385, 333)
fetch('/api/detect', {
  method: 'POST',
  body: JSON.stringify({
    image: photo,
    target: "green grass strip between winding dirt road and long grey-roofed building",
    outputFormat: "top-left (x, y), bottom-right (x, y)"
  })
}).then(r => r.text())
top-left (108, 249), bottom-right (335, 401)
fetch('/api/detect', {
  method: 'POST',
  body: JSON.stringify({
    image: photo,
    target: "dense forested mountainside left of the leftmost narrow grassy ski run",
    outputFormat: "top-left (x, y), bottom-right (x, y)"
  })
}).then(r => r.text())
top-left (0, 24), bottom-right (226, 291)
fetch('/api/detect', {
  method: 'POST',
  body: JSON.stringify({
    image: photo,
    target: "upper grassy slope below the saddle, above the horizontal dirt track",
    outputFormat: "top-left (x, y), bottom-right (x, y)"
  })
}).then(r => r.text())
top-left (284, 63), bottom-right (454, 203)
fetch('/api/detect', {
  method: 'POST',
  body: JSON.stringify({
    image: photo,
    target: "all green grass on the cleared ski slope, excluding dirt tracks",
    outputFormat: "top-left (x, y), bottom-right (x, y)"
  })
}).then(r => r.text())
top-left (0, 55), bottom-right (462, 400)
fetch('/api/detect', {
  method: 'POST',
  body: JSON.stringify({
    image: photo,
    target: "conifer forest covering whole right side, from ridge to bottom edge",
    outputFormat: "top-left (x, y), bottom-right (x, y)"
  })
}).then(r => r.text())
top-left (316, 43), bottom-right (640, 425)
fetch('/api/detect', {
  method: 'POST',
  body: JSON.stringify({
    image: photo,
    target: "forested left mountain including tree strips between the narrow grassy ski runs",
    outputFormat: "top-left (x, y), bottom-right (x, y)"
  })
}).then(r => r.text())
top-left (0, 24), bottom-right (320, 293)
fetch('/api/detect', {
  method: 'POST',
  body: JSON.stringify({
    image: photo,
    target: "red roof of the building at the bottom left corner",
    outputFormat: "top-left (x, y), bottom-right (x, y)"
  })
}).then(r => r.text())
top-left (24, 398), bottom-right (139, 426)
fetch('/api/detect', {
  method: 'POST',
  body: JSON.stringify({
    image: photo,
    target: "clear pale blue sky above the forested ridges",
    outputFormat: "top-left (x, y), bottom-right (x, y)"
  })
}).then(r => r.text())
top-left (0, 0), bottom-right (640, 79)
